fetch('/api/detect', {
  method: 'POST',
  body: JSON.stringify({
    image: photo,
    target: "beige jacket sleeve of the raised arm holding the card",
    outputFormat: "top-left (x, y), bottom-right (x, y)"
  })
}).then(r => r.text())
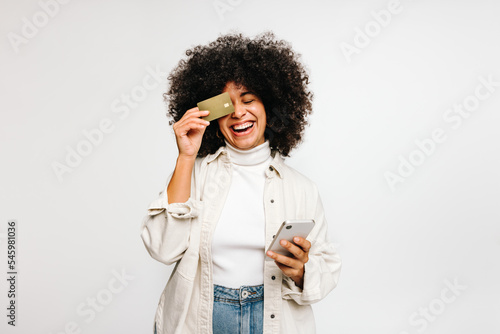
top-left (140, 175), bottom-right (201, 265)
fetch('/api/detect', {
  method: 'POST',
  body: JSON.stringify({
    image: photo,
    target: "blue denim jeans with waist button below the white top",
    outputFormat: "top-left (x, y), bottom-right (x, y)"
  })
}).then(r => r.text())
top-left (212, 284), bottom-right (264, 334)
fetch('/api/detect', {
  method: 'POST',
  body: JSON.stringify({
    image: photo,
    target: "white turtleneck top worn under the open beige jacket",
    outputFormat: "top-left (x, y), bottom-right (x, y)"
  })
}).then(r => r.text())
top-left (212, 141), bottom-right (272, 289)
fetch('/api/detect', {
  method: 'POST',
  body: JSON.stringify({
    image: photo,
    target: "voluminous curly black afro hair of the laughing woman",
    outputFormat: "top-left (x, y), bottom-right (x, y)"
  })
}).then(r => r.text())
top-left (163, 32), bottom-right (313, 157)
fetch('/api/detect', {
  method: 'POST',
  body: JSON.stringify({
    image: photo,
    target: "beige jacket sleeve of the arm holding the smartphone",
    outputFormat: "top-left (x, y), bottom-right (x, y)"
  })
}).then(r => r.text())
top-left (282, 186), bottom-right (342, 305)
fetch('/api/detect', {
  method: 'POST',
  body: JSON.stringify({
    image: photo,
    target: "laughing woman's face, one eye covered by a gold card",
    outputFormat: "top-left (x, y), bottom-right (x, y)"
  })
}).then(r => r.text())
top-left (217, 82), bottom-right (266, 150)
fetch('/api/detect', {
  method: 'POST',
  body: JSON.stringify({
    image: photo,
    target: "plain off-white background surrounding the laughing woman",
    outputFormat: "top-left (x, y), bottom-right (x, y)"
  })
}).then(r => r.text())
top-left (0, 0), bottom-right (500, 334)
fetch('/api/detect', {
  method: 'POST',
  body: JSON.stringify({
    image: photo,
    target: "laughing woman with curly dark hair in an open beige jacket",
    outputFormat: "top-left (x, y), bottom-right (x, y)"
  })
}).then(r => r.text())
top-left (141, 33), bottom-right (341, 334)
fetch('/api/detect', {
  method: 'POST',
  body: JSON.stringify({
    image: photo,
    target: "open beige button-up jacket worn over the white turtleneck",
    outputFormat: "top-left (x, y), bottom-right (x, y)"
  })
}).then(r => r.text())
top-left (141, 147), bottom-right (341, 334)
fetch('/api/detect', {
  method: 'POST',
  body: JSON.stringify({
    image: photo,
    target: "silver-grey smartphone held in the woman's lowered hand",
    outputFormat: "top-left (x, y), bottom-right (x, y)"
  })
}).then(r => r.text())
top-left (266, 219), bottom-right (314, 260)
